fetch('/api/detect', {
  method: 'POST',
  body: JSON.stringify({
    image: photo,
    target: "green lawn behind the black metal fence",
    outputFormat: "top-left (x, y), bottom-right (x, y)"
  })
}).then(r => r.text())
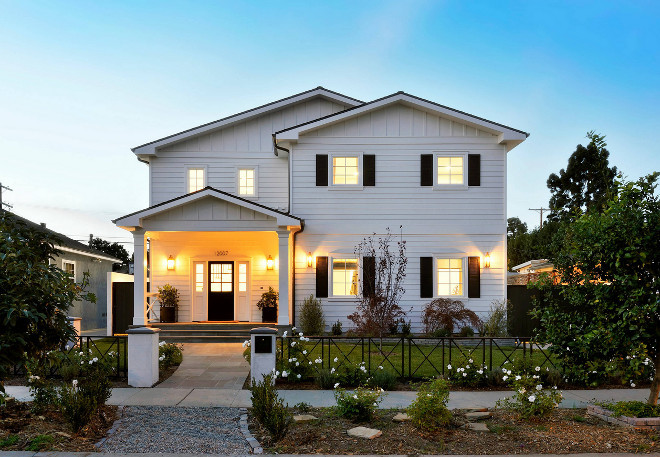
top-left (278, 338), bottom-right (554, 378)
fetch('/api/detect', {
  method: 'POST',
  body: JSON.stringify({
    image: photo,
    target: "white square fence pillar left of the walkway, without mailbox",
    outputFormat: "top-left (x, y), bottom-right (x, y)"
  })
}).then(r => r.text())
top-left (126, 327), bottom-right (160, 387)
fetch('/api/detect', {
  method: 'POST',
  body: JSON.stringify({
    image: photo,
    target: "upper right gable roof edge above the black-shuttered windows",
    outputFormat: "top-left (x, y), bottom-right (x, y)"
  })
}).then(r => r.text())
top-left (273, 91), bottom-right (529, 150)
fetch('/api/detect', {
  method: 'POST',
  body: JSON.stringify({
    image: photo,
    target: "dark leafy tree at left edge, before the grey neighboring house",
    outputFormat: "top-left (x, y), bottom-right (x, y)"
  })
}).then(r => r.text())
top-left (0, 211), bottom-right (96, 391)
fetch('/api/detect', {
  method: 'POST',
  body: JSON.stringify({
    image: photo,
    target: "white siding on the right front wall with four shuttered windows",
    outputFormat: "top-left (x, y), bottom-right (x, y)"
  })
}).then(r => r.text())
top-left (290, 105), bottom-right (506, 331)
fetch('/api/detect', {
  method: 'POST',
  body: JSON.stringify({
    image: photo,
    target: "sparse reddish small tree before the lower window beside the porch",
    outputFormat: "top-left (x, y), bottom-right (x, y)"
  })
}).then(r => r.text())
top-left (348, 227), bottom-right (408, 343)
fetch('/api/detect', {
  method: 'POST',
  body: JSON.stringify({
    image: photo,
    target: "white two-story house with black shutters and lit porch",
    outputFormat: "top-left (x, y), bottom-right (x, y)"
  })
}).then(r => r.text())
top-left (114, 87), bottom-right (528, 331)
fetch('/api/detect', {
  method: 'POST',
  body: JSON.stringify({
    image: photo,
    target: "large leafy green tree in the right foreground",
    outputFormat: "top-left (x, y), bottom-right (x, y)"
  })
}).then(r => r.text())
top-left (537, 173), bottom-right (660, 404)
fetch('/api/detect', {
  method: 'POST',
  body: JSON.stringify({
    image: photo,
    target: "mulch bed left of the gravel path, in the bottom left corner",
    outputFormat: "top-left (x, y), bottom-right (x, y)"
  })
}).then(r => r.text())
top-left (0, 399), bottom-right (117, 452)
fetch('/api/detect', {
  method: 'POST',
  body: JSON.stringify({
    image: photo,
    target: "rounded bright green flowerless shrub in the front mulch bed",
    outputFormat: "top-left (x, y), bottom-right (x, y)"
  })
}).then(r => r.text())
top-left (407, 378), bottom-right (451, 431)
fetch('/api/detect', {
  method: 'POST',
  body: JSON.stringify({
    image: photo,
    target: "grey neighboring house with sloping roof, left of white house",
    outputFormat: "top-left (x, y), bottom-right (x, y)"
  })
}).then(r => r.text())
top-left (4, 210), bottom-right (121, 335)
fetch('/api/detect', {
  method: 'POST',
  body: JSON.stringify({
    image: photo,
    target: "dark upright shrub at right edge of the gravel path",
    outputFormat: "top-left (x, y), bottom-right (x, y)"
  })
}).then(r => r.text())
top-left (250, 374), bottom-right (291, 441)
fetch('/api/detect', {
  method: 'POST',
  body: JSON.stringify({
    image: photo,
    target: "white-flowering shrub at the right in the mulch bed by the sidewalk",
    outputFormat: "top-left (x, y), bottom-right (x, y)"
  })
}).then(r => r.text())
top-left (497, 367), bottom-right (562, 419)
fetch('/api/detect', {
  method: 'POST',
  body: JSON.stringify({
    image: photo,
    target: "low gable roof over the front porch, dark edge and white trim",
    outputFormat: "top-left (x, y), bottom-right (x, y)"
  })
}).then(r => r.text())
top-left (112, 186), bottom-right (303, 227)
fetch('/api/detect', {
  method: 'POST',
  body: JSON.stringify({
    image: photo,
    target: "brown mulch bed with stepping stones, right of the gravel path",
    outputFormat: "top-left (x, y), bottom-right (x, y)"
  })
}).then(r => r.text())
top-left (250, 408), bottom-right (660, 455)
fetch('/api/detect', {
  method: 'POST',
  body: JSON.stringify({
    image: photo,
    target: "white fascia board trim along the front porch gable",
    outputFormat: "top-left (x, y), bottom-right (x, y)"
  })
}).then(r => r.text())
top-left (114, 189), bottom-right (300, 230)
